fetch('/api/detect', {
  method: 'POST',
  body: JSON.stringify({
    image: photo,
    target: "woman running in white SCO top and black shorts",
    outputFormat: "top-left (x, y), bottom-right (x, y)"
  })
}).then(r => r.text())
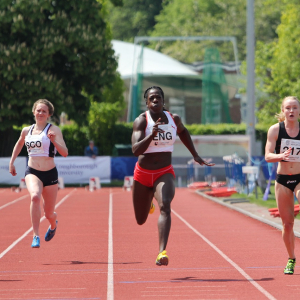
top-left (9, 99), bottom-right (68, 248)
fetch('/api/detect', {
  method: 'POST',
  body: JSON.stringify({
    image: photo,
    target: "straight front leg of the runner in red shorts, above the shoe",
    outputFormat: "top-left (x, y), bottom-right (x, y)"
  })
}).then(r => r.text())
top-left (154, 173), bottom-right (175, 253)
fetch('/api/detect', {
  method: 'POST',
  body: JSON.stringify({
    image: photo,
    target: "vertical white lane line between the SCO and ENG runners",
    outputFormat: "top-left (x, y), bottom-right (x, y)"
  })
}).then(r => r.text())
top-left (107, 189), bottom-right (114, 300)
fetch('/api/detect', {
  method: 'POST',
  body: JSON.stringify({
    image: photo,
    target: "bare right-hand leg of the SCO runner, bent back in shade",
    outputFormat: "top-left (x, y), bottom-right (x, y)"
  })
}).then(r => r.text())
top-left (42, 184), bottom-right (58, 229)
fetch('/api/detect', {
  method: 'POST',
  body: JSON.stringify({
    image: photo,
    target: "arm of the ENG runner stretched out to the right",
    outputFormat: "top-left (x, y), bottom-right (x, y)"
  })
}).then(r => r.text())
top-left (172, 114), bottom-right (215, 166)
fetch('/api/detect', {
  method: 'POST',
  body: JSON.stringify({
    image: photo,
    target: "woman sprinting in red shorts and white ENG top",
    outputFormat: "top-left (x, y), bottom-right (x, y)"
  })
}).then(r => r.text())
top-left (132, 86), bottom-right (214, 266)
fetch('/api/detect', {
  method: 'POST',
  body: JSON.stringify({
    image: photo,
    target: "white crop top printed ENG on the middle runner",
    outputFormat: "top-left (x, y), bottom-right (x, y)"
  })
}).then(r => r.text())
top-left (144, 110), bottom-right (177, 153)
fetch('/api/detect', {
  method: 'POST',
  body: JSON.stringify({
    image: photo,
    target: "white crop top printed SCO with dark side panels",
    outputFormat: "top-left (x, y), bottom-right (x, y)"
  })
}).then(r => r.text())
top-left (25, 123), bottom-right (56, 157)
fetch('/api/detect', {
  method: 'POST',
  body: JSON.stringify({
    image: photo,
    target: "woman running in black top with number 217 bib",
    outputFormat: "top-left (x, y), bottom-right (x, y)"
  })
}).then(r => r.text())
top-left (265, 96), bottom-right (300, 274)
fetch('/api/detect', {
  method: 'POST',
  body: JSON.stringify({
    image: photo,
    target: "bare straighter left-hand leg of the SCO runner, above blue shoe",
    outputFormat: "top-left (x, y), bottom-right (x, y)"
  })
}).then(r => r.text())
top-left (25, 174), bottom-right (43, 236)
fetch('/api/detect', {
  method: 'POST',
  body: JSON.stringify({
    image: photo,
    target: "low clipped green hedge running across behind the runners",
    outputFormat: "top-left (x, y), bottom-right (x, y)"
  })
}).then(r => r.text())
top-left (11, 123), bottom-right (268, 156)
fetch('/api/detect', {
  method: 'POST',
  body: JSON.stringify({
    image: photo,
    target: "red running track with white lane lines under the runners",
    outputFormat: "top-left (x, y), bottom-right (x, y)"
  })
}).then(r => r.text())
top-left (0, 188), bottom-right (300, 300)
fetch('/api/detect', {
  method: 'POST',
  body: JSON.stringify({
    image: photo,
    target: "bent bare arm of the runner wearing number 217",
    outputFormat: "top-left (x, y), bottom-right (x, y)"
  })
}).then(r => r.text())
top-left (265, 124), bottom-right (292, 162)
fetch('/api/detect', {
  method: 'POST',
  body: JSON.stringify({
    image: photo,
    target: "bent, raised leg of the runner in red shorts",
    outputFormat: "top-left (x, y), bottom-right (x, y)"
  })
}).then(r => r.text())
top-left (132, 180), bottom-right (153, 225)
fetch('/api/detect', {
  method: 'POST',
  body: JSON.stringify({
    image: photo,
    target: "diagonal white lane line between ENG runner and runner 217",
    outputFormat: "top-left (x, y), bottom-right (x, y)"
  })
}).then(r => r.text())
top-left (172, 209), bottom-right (276, 300)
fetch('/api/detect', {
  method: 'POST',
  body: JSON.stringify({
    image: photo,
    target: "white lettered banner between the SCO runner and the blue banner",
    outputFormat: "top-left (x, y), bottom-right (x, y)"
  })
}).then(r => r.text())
top-left (54, 156), bottom-right (111, 184)
